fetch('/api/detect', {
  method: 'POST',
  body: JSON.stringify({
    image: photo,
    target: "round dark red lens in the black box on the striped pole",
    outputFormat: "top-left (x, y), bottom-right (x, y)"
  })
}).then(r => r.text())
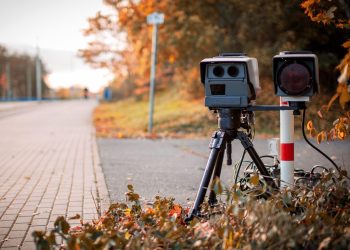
top-left (279, 63), bottom-right (311, 95)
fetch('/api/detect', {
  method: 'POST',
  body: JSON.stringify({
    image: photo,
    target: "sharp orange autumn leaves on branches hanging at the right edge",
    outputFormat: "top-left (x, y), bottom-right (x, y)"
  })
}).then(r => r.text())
top-left (301, 0), bottom-right (350, 143)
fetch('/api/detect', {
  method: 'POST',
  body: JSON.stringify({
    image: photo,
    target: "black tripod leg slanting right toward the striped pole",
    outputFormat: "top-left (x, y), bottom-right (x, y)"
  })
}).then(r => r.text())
top-left (237, 132), bottom-right (277, 189)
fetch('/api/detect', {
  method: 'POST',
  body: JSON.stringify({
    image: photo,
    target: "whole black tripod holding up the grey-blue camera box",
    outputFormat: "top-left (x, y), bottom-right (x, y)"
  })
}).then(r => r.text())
top-left (186, 108), bottom-right (277, 221)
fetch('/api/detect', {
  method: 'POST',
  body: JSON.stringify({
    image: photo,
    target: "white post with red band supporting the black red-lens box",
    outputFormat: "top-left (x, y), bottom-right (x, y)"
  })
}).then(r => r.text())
top-left (280, 97), bottom-right (294, 189)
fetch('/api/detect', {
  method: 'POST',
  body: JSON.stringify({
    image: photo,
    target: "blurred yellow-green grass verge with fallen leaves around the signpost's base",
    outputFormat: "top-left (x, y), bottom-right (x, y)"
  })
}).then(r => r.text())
top-left (93, 91), bottom-right (217, 138)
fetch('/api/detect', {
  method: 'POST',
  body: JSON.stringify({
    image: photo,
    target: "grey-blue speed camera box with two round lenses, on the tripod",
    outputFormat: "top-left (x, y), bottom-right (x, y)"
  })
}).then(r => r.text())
top-left (200, 53), bottom-right (260, 109)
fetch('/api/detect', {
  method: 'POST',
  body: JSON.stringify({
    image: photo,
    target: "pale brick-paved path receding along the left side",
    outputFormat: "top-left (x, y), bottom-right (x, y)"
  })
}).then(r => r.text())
top-left (0, 100), bottom-right (109, 249)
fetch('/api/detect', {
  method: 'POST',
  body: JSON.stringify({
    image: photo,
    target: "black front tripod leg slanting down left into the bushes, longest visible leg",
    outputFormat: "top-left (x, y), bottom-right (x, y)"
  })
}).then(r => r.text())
top-left (186, 131), bottom-right (225, 221)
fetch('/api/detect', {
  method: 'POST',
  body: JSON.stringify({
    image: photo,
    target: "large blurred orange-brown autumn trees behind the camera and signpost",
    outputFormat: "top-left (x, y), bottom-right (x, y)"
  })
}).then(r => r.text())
top-left (80, 0), bottom-right (349, 98)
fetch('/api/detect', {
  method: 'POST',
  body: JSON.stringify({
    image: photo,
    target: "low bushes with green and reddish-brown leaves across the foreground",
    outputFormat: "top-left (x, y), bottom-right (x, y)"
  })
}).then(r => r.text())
top-left (33, 173), bottom-right (350, 249)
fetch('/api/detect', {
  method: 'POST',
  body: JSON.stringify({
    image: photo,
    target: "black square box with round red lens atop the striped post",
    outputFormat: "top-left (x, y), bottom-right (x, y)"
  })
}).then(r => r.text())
top-left (273, 51), bottom-right (320, 98)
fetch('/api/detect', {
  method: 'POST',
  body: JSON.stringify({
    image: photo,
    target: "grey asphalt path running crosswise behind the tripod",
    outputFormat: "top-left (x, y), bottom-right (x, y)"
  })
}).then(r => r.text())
top-left (98, 138), bottom-right (350, 204)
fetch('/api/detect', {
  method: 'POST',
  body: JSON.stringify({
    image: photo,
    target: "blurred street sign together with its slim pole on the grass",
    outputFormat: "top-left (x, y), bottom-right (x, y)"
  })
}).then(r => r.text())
top-left (147, 12), bottom-right (164, 134)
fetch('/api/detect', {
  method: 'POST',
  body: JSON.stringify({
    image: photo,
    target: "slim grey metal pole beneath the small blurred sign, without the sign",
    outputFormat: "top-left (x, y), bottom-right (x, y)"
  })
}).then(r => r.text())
top-left (148, 24), bottom-right (158, 134)
